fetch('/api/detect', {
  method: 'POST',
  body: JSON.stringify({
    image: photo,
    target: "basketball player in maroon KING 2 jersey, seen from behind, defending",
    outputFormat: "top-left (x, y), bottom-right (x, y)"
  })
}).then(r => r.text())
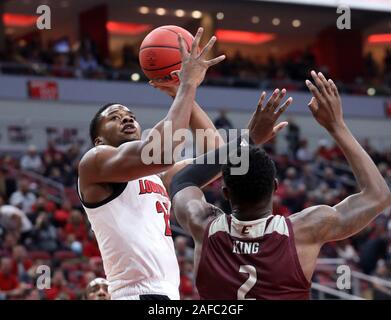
top-left (171, 71), bottom-right (391, 300)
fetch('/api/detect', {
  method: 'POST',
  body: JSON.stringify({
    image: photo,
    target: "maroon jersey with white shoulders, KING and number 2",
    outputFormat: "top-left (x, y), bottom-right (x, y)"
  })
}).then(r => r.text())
top-left (196, 214), bottom-right (311, 300)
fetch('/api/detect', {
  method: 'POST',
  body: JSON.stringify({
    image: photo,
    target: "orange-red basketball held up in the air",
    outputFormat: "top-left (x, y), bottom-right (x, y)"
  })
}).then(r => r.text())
top-left (139, 26), bottom-right (194, 85)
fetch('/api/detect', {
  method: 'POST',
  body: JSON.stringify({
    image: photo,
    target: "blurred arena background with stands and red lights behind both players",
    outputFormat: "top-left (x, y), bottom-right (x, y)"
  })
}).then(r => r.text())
top-left (0, 0), bottom-right (391, 300)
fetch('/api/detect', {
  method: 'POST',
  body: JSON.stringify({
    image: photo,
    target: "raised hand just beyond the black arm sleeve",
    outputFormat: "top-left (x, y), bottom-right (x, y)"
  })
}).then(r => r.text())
top-left (247, 89), bottom-right (293, 144)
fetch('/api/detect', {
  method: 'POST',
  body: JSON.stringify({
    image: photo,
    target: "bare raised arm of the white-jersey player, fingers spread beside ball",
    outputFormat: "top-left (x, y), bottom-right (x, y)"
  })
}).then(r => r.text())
top-left (79, 28), bottom-right (225, 183)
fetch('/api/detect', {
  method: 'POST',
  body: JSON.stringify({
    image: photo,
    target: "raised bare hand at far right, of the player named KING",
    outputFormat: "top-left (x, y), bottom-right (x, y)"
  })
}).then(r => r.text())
top-left (305, 71), bottom-right (344, 132)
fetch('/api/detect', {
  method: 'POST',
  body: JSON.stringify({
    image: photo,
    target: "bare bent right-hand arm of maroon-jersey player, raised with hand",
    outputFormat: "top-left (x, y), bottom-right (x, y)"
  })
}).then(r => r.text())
top-left (291, 71), bottom-right (391, 244)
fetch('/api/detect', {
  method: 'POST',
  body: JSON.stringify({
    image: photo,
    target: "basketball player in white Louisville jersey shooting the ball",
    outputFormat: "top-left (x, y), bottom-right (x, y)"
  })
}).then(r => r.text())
top-left (78, 28), bottom-right (225, 300)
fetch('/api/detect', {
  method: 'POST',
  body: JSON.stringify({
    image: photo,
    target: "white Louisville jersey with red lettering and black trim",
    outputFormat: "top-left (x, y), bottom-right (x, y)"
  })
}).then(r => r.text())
top-left (77, 175), bottom-right (179, 299)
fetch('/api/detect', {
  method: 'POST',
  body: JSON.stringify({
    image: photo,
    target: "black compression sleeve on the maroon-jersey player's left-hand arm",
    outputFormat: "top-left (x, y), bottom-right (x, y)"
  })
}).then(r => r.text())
top-left (170, 134), bottom-right (254, 199)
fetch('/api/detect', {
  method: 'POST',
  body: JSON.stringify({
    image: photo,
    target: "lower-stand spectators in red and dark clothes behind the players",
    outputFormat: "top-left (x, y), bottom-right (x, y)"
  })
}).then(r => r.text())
top-left (0, 114), bottom-right (391, 300)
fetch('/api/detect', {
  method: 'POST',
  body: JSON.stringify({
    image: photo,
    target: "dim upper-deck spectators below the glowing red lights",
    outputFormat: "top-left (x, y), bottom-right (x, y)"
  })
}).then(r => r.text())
top-left (0, 38), bottom-right (391, 94)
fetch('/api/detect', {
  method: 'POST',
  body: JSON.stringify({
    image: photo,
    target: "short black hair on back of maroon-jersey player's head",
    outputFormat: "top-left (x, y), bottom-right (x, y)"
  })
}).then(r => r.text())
top-left (222, 146), bottom-right (277, 203)
